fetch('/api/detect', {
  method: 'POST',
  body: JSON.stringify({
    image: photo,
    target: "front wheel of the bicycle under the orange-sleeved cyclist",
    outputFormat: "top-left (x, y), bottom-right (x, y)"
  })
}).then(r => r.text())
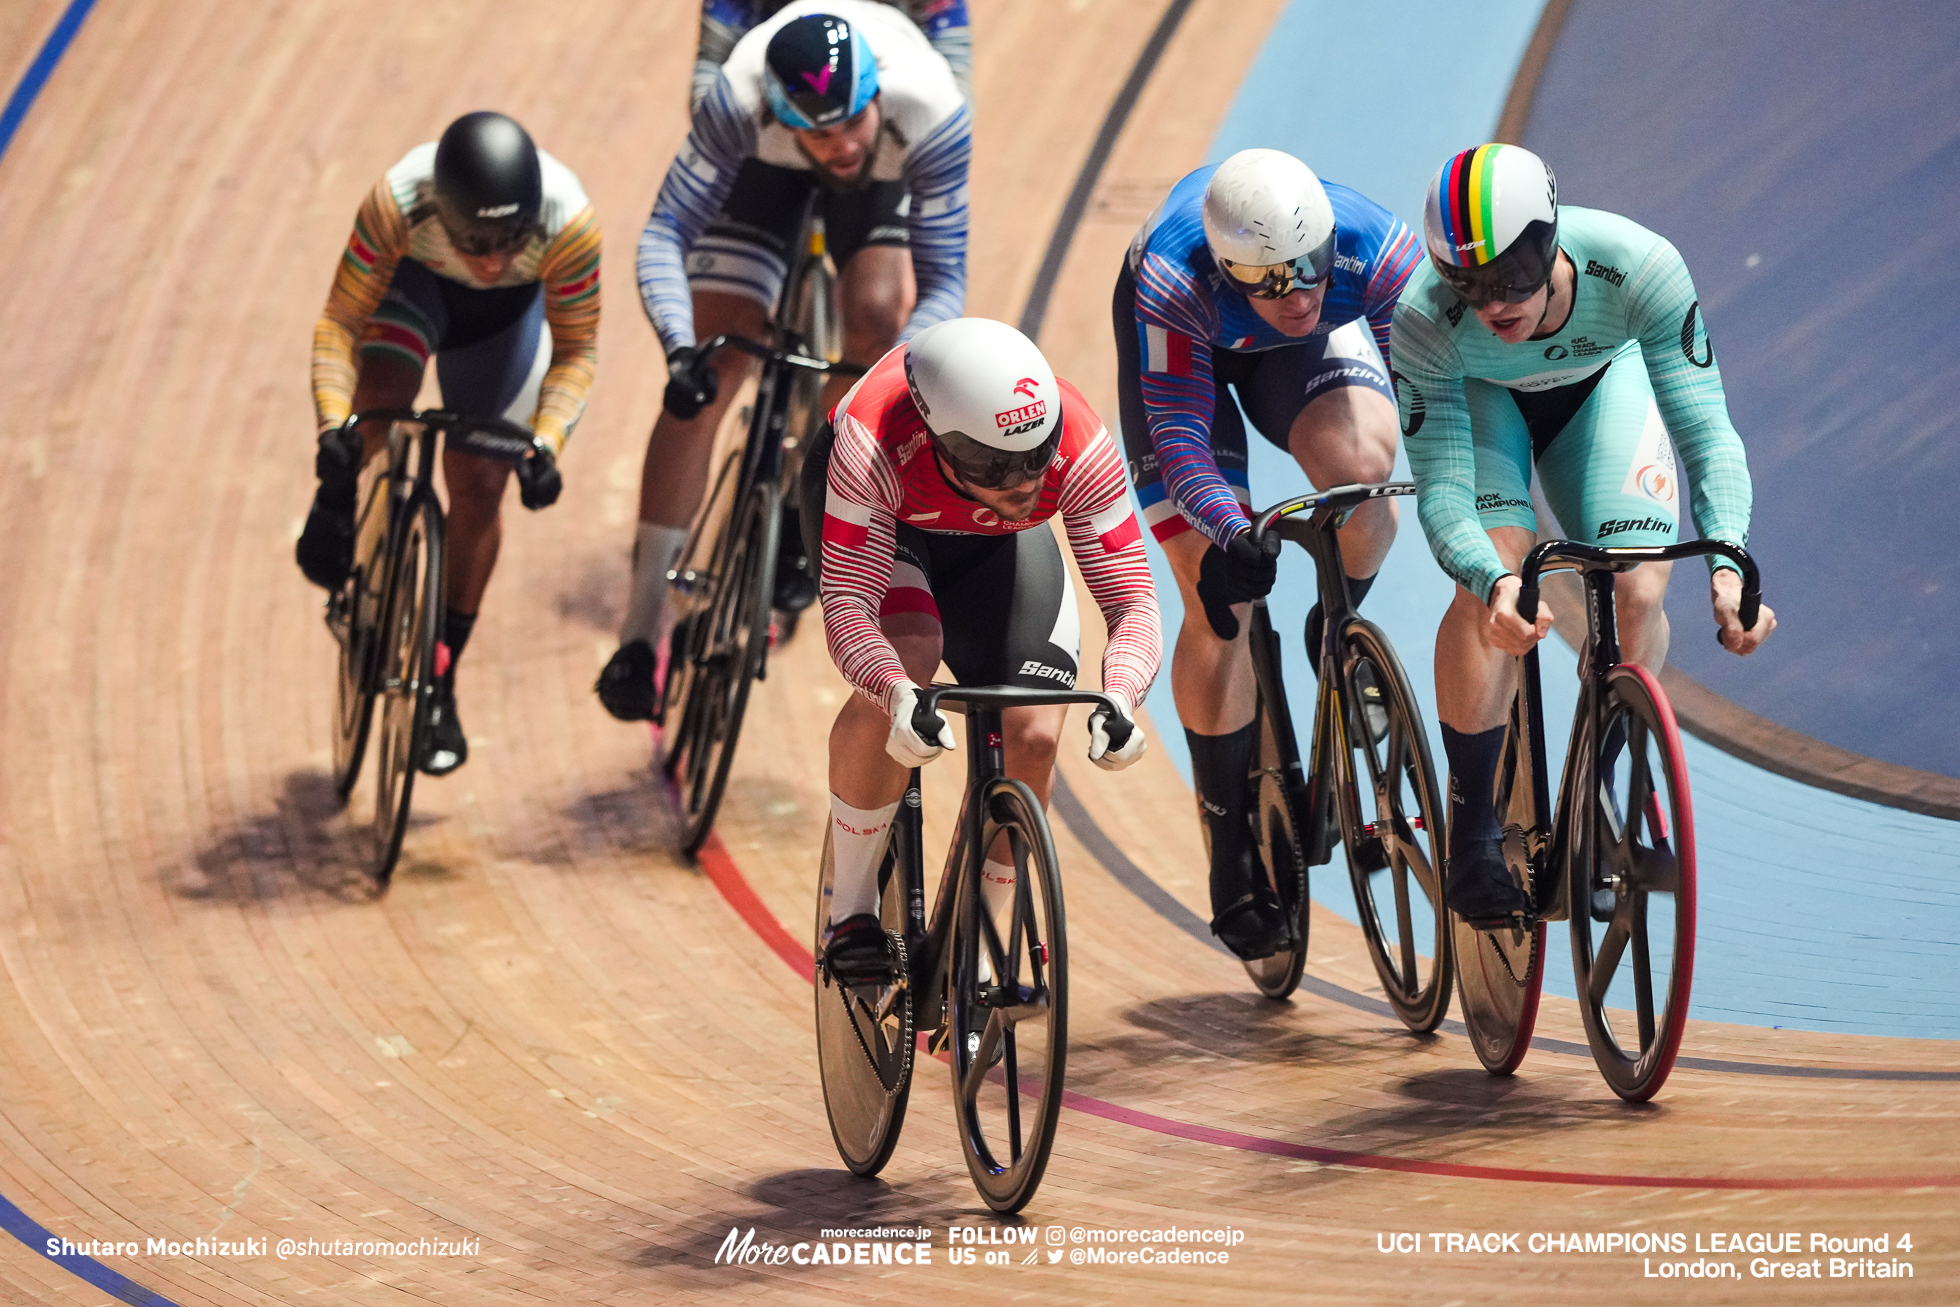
top-left (372, 498), bottom-right (443, 890)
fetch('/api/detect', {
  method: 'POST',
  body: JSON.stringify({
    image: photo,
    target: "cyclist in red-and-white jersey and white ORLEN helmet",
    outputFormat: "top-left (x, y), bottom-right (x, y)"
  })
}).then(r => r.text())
top-left (804, 317), bottom-right (1162, 976)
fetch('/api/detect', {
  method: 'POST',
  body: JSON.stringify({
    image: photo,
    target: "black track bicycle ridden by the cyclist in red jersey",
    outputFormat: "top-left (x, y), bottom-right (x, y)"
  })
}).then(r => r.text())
top-left (815, 686), bottom-right (1133, 1213)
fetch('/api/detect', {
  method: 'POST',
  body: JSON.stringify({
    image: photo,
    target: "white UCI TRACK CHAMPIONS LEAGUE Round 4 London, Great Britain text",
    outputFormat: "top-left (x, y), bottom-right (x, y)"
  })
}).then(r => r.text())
top-left (1374, 1231), bottom-right (1913, 1280)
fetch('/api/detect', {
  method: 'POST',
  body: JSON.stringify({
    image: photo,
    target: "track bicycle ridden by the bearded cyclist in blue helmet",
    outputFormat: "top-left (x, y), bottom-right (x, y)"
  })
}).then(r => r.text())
top-left (655, 208), bottom-right (862, 856)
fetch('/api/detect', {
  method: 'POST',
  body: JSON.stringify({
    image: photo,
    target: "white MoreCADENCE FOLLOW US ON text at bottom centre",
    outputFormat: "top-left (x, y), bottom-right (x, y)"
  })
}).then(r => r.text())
top-left (713, 1225), bottom-right (1245, 1268)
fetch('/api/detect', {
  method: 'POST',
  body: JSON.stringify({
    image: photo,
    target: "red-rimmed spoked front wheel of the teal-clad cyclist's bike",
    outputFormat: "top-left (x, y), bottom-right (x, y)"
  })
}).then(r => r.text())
top-left (1568, 662), bottom-right (1695, 1103)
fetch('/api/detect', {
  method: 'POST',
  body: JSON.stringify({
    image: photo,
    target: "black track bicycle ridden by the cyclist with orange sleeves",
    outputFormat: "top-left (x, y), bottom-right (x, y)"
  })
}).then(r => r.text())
top-left (327, 410), bottom-right (541, 892)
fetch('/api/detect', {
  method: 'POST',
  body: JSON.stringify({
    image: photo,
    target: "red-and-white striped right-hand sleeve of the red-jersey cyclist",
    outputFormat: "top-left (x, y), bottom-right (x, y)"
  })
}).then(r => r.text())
top-left (1058, 427), bottom-right (1164, 703)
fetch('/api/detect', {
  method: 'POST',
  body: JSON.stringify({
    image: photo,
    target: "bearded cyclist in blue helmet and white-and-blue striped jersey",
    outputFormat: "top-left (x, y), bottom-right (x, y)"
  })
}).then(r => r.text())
top-left (596, 0), bottom-right (972, 721)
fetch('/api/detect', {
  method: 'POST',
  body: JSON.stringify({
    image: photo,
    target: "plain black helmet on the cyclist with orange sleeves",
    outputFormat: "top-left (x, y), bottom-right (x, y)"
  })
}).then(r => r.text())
top-left (435, 110), bottom-right (545, 255)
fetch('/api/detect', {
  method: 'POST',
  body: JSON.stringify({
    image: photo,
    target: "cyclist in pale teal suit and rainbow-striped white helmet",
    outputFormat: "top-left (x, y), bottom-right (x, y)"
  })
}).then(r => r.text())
top-left (1392, 145), bottom-right (1776, 921)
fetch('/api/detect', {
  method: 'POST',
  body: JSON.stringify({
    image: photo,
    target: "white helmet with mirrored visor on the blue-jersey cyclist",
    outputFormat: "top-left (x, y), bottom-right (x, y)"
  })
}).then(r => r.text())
top-left (1205, 149), bottom-right (1335, 300)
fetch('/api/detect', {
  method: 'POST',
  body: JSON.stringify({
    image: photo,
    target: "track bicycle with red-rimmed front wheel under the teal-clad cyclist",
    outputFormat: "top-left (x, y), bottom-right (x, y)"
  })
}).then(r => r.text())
top-left (1450, 541), bottom-right (1762, 1103)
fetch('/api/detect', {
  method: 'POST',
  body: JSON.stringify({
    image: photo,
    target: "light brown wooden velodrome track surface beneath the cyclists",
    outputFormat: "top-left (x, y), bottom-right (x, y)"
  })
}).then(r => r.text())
top-left (0, 0), bottom-right (1960, 1307)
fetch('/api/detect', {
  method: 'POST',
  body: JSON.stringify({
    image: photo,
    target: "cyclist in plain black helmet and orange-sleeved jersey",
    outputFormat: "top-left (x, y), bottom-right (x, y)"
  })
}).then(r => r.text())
top-left (298, 112), bottom-right (600, 776)
